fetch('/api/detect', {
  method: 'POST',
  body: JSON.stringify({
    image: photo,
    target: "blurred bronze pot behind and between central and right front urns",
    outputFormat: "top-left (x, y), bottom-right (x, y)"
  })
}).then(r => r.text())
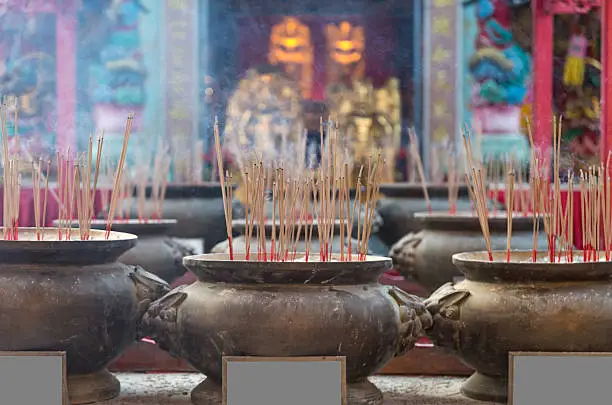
top-left (389, 212), bottom-right (547, 293)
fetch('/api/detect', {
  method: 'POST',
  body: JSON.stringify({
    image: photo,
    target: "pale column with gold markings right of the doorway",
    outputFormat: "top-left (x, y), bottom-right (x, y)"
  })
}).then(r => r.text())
top-left (421, 0), bottom-right (460, 170)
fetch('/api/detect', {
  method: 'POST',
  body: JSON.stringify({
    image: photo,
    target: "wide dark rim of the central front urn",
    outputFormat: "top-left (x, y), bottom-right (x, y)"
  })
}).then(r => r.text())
top-left (183, 252), bottom-right (393, 285)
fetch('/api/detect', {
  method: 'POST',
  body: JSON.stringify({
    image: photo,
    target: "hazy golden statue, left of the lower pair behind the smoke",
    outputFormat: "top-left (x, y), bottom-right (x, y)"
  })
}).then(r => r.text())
top-left (224, 67), bottom-right (305, 173)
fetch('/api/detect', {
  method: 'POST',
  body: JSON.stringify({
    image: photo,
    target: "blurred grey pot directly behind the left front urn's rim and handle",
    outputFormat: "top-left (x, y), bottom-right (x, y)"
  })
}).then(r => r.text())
top-left (53, 219), bottom-right (195, 284)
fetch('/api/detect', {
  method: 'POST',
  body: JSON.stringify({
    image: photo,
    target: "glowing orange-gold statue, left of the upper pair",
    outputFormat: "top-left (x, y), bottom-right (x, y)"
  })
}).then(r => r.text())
top-left (268, 17), bottom-right (314, 99)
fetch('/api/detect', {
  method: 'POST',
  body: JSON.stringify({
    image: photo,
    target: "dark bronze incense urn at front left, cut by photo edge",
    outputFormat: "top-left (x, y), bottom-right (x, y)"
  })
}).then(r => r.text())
top-left (0, 228), bottom-right (170, 405)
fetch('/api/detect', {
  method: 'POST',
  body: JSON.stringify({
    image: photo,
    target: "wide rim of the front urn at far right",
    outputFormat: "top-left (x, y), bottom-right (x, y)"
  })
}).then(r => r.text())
top-left (452, 250), bottom-right (612, 282)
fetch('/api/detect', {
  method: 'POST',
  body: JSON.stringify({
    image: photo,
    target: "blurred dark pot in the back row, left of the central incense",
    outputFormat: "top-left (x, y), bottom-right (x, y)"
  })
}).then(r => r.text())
top-left (140, 183), bottom-right (227, 251)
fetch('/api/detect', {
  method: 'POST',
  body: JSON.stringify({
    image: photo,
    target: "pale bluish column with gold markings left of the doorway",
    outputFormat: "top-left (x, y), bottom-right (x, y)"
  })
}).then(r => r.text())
top-left (163, 0), bottom-right (200, 182)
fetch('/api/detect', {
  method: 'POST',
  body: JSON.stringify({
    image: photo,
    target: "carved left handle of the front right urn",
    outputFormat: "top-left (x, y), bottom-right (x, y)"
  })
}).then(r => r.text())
top-left (424, 283), bottom-right (470, 351)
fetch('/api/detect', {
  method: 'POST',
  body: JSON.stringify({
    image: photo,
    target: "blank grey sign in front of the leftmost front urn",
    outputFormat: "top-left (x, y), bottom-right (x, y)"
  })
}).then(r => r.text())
top-left (0, 352), bottom-right (67, 405)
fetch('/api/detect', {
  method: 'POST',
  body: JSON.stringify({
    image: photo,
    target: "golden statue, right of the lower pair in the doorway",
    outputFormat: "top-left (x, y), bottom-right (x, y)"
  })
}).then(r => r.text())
top-left (327, 78), bottom-right (401, 182)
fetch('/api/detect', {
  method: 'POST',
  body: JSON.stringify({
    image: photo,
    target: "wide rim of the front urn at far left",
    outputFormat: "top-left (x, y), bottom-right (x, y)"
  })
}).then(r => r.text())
top-left (0, 227), bottom-right (138, 266)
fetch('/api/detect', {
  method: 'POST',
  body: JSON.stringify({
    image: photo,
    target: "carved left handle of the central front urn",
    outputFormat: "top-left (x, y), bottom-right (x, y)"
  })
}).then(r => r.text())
top-left (139, 285), bottom-right (187, 357)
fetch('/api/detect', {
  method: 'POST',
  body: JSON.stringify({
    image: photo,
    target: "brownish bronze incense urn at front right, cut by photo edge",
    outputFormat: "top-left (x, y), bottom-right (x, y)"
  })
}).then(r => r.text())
top-left (425, 250), bottom-right (612, 403)
